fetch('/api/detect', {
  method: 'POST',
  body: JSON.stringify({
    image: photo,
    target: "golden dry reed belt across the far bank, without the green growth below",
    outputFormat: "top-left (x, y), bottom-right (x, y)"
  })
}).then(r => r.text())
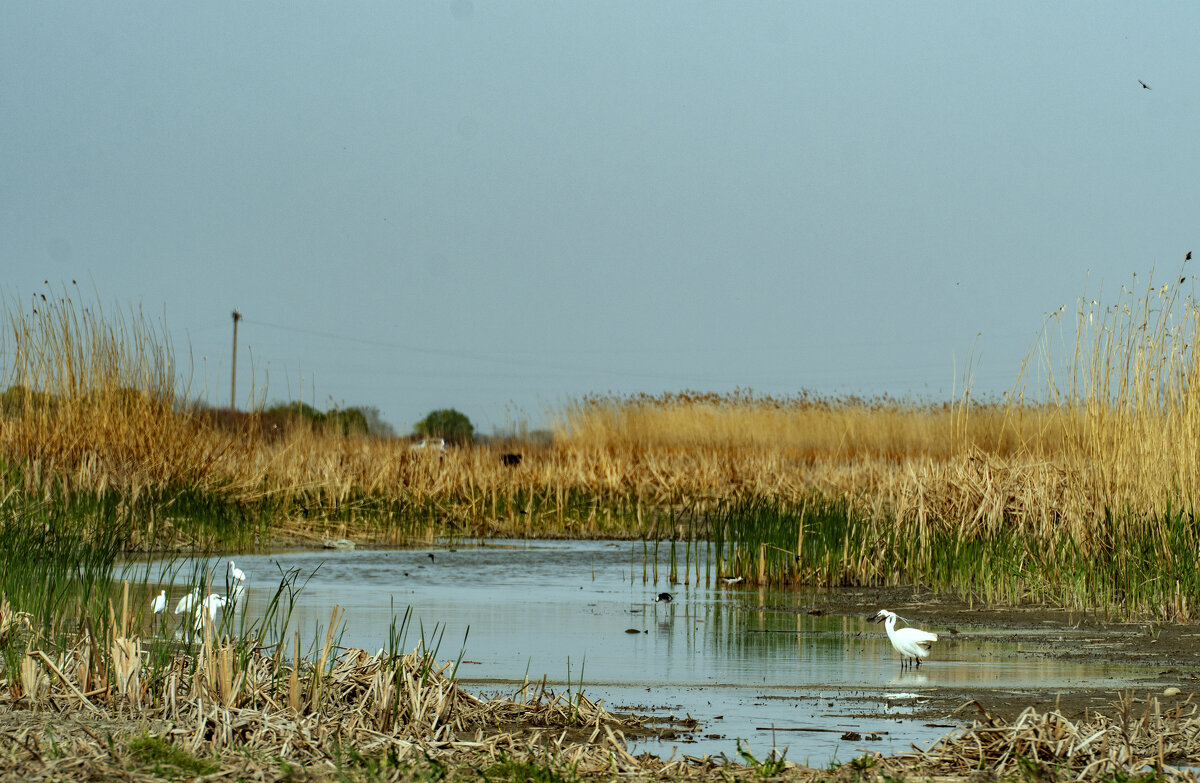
top-left (0, 276), bottom-right (1200, 562)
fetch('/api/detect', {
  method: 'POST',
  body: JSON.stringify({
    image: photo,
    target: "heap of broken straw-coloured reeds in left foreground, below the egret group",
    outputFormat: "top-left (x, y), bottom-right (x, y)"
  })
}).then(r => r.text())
top-left (0, 574), bottom-right (667, 775)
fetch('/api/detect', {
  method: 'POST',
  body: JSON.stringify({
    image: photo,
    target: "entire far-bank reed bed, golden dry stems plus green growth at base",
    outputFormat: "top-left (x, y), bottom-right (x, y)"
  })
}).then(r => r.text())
top-left (7, 286), bottom-right (1200, 621)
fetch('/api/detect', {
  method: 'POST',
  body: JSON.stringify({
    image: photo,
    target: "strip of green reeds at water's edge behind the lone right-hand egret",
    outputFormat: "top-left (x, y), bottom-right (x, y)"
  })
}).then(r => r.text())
top-left (676, 497), bottom-right (1200, 620)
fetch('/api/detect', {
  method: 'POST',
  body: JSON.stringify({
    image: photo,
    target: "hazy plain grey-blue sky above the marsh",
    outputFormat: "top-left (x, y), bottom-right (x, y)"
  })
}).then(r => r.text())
top-left (0, 0), bottom-right (1200, 434)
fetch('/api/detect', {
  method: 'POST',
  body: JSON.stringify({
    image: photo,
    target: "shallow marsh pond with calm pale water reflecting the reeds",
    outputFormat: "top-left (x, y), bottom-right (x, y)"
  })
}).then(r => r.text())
top-left (142, 540), bottom-right (1180, 766)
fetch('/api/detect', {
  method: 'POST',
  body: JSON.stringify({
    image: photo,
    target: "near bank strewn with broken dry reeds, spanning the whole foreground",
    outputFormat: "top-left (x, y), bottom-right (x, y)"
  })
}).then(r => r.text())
top-left (0, 593), bottom-right (1200, 783)
